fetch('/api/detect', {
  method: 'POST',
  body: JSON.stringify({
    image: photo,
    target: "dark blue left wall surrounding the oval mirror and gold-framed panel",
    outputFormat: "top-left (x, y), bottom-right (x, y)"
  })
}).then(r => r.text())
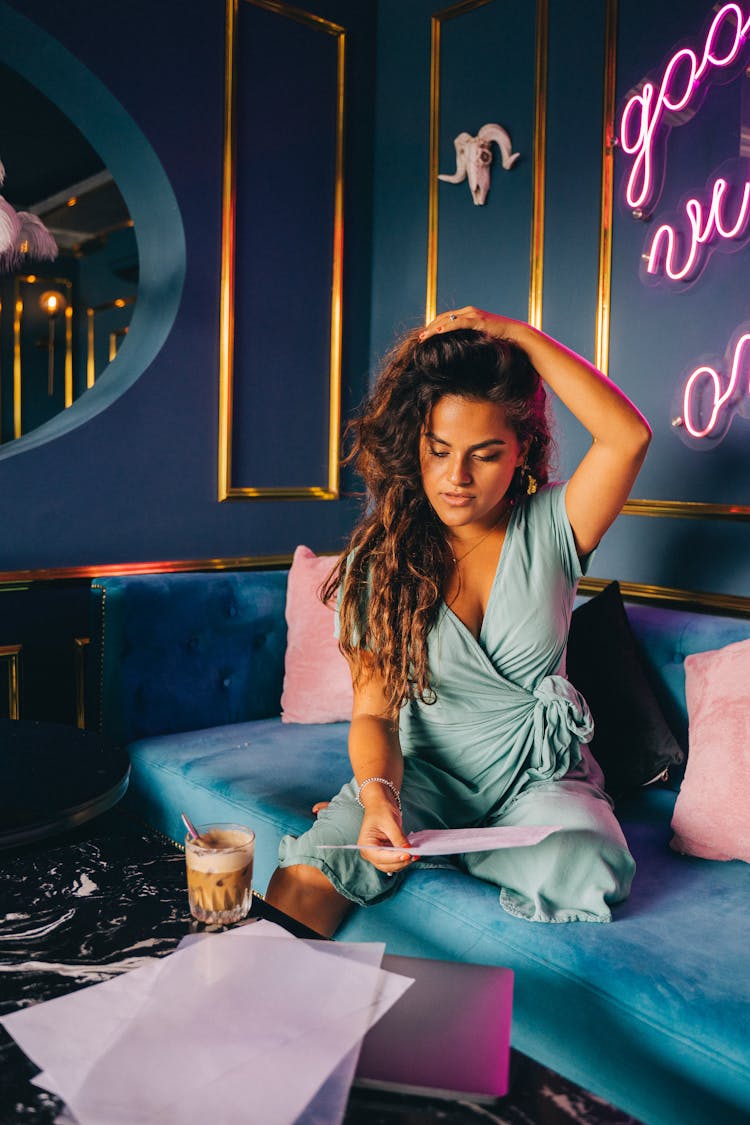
top-left (0, 0), bottom-right (374, 570)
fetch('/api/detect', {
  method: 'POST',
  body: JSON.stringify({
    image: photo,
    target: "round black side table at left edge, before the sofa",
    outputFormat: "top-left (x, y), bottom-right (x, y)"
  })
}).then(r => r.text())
top-left (0, 719), bottom-right (130, 848)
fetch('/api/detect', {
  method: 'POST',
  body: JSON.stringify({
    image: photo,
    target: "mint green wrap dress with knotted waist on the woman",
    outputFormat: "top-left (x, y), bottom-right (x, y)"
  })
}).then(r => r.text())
top-left (279, 484), bottom-right (635, 921)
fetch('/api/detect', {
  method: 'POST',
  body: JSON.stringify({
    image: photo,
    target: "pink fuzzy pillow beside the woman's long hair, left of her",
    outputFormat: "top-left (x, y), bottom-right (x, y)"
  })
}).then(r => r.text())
top-left (281, 547), bottom-right (352, 722)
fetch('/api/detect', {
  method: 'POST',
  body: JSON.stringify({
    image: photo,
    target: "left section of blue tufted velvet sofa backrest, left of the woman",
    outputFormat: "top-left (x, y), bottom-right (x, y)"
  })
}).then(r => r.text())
top-left (92, 570), bottom-right (288, 743)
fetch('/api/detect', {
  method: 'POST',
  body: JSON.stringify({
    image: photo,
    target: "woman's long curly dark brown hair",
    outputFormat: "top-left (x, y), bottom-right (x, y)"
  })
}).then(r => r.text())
top-left (322, 329), bottom-right (552, 713)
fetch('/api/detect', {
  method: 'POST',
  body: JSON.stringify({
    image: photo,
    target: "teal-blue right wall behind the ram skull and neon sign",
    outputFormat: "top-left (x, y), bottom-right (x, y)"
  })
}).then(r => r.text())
top-left (372, 0), bottom-right (750, 595)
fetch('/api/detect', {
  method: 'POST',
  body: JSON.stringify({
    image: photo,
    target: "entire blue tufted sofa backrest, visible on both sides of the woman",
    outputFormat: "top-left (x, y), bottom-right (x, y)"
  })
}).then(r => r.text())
top-left (92, 570), bottom-right (750, 746)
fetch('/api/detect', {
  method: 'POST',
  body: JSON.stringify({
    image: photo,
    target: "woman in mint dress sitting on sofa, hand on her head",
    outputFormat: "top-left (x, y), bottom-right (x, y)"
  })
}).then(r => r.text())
top-left (266, 307), bottom-right (651, 935)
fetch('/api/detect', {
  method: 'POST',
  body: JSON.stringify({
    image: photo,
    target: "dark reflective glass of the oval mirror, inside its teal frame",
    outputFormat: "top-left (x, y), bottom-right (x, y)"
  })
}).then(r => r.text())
top-left (0, 62), bottom-right (138, 444)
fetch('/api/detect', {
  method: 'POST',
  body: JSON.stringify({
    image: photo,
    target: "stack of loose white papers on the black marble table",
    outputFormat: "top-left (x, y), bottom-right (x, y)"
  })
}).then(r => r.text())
top-left (1, 921), bottom-right (412, 1125)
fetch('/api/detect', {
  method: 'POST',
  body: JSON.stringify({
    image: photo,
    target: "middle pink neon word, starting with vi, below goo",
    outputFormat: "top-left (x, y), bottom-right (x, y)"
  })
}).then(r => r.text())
top-left (642, 161), bottom-right (750, 285)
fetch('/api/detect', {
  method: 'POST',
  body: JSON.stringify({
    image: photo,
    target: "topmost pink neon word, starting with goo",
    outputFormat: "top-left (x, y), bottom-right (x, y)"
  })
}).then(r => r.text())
top-left (620, 3), bottom-right (750, 210)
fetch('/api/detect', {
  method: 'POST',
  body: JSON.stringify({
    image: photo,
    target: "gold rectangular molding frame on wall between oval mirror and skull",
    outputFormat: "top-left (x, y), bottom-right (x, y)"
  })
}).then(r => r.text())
top-left (218, 0), bottom-right (346, 501)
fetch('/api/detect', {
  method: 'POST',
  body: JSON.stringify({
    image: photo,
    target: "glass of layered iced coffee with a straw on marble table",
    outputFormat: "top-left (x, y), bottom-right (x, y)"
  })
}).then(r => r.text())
top-left (184, 825), bottom-right (255, 926)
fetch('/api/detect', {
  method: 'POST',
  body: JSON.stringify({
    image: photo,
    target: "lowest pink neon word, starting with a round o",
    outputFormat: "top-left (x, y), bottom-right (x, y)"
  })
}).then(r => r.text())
top-left (675, 332), bottom-right (750, 446)
